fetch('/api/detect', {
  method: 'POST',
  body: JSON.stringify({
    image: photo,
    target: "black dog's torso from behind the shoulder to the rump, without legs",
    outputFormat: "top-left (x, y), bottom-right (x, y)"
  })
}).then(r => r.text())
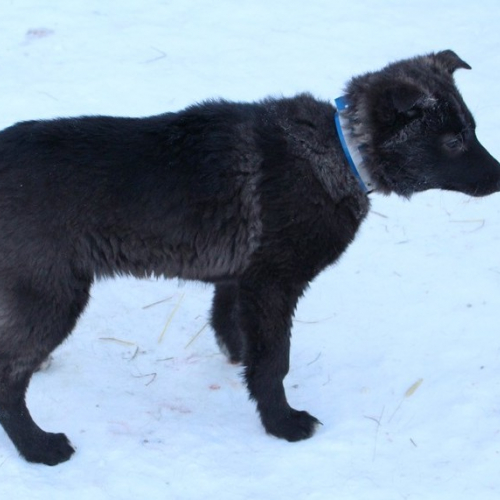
top-left (0, 103), bottom-right (260, 280)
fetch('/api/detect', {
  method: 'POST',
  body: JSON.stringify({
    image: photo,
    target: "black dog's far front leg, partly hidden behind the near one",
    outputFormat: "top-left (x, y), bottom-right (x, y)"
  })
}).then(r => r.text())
top-left (211, 283), bottom-right (244, 363)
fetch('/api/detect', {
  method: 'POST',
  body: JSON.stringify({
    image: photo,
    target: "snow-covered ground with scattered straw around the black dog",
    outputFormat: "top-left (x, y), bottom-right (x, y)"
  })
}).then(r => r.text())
top-left (0, 0), bottom-right (500, 500)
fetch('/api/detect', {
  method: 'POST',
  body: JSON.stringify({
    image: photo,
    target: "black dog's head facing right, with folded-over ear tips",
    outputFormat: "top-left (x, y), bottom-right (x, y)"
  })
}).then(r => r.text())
top-left (346, 50), bottom-right (500, 197)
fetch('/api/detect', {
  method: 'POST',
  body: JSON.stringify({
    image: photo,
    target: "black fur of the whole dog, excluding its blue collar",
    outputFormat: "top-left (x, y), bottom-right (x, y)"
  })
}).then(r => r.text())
top-left (0, 51), bottom-right (500, 465)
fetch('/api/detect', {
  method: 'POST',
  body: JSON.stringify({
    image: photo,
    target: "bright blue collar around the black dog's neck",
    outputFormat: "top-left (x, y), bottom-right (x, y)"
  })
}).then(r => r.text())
top-left (335, 97), bottom-right (377, 194)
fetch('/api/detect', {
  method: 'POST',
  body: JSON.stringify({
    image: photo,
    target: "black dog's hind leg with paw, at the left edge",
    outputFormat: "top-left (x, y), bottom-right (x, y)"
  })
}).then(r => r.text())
top-left (0, 279), bottom-right (91, 465)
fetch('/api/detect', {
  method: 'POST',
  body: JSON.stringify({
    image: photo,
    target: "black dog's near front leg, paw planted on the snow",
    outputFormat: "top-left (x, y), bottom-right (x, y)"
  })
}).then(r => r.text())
top-left (239, 277), bottom-right (320, 441)
